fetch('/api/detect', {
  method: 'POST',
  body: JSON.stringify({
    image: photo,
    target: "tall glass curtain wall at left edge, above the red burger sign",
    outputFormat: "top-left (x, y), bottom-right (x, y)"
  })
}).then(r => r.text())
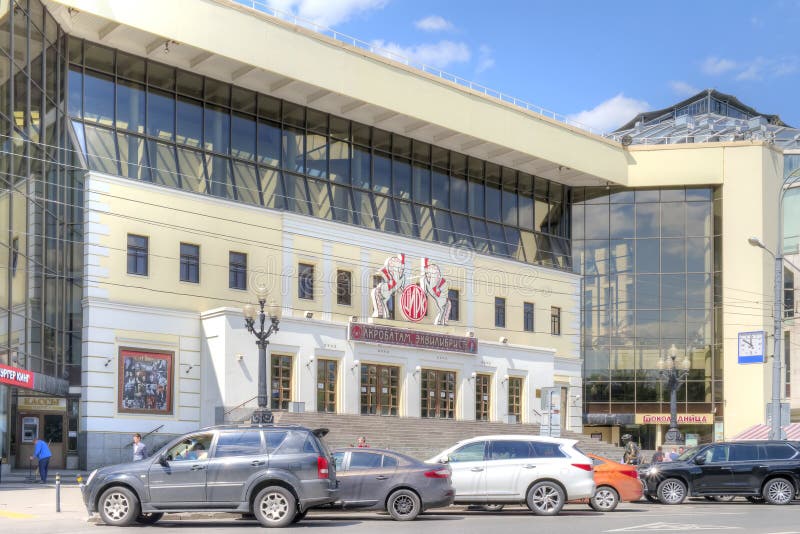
top-left (0, 0), bottom-right (83, 455)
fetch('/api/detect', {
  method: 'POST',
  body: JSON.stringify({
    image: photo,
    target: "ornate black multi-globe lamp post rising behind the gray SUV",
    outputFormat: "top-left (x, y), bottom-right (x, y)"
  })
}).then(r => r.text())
top-left (242, 287), bottom-right (281, 424)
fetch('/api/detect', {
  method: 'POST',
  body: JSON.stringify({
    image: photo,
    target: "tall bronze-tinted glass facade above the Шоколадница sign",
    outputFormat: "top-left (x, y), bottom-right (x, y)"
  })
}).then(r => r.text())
top-left (572, 188), bottom-right (724, 446)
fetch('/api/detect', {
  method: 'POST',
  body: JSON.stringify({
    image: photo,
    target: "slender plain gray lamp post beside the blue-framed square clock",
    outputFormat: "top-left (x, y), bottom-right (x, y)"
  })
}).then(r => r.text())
top-left (747, 169), bottom-right (800, 439)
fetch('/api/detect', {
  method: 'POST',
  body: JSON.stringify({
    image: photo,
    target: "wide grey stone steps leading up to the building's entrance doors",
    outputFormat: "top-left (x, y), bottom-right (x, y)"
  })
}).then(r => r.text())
top-left (262, 412), bottom-right (622, 461)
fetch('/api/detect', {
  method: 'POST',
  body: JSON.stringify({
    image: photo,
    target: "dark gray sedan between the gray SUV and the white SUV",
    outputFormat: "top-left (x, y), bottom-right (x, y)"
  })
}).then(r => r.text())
top-left (331, 448), bottom-right (455, 521)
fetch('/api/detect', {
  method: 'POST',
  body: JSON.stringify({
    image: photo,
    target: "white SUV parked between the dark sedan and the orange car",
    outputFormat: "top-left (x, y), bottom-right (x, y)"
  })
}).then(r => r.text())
top-left (428, 436), bottom-right (594, 515)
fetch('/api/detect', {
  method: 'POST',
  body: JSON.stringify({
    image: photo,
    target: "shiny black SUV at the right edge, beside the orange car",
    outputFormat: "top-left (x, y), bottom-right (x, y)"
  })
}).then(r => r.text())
top-left (639, 441), bottom-right (800, 504)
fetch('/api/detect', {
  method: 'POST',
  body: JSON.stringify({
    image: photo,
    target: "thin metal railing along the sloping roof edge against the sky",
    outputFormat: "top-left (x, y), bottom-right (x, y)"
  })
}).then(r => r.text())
top-left (228, 0), bottom-right (606, 137)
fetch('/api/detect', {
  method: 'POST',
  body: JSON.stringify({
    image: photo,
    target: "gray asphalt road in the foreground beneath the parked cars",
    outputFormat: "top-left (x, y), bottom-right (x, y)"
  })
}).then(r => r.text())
top-left (6, 497), bottom-right (800, 534)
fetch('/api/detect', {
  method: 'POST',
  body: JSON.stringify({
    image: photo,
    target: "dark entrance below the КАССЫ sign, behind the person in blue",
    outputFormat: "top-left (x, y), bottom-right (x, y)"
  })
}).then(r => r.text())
top-left (17, 413), bottom-right (67, 469)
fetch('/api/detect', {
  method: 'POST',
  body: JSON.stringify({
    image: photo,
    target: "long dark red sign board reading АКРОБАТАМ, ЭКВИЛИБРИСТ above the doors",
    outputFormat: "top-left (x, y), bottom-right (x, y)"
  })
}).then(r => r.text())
top-left (348, 323), bottom-right (478, 354)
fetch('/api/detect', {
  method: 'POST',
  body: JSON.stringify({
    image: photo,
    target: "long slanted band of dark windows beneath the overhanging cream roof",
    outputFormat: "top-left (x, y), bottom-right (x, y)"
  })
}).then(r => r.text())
top-left (69, 38), bottom-right (570, 269)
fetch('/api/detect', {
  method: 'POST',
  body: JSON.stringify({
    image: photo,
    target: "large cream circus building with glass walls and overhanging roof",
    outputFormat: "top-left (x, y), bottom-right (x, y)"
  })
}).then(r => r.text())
top-left (0, 0), bottom-right (783, 468)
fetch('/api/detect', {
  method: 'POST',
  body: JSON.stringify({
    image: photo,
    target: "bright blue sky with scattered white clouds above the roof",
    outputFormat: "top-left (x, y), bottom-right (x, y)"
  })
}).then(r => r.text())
top-left (260, 0), bottom-right (800, 131)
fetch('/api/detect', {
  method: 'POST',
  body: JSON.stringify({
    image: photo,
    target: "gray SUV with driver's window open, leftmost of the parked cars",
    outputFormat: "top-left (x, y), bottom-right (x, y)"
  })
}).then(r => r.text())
top-left (82, 425), bottom-right (338, 527)
